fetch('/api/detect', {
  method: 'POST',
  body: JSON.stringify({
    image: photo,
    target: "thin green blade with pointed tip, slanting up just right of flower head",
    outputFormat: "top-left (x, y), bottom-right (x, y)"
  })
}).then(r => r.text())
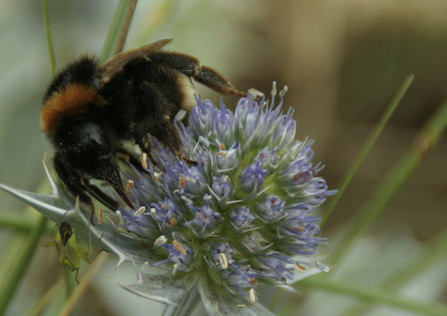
top-left (320, 75), bottom-right (414, 227)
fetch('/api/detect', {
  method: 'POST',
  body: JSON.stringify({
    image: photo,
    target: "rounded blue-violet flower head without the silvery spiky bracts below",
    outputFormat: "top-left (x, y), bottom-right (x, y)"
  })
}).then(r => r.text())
top-left (117, 85), bottom-right (336, 301)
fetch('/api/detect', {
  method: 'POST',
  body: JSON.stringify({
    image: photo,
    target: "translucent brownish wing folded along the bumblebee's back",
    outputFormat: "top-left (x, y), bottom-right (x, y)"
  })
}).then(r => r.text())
top-left (97, 38), bottom-right (173, 87)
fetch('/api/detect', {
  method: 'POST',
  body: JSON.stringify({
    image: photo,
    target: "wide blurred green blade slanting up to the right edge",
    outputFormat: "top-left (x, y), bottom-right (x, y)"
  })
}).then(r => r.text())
top-left (331, 97), bottom-right (447, 264)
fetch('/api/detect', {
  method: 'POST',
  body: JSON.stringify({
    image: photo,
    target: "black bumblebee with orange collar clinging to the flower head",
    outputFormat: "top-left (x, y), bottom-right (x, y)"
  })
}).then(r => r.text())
top-left (41, 39), bottom-right (246, 221)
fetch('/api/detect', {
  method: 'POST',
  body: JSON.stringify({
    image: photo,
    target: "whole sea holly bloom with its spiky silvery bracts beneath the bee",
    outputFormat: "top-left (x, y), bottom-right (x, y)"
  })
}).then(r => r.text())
top-left (3, 85), bottom-right (336, 315)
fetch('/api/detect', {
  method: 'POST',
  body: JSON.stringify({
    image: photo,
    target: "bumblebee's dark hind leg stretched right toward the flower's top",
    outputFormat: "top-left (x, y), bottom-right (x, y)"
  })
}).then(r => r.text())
top-left (150, 51), bottom-right (247, 97)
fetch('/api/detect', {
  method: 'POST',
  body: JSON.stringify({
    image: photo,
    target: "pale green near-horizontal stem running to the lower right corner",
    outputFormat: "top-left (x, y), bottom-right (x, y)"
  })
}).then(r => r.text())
top-left (300, 276), bottom-right (447, 316)
